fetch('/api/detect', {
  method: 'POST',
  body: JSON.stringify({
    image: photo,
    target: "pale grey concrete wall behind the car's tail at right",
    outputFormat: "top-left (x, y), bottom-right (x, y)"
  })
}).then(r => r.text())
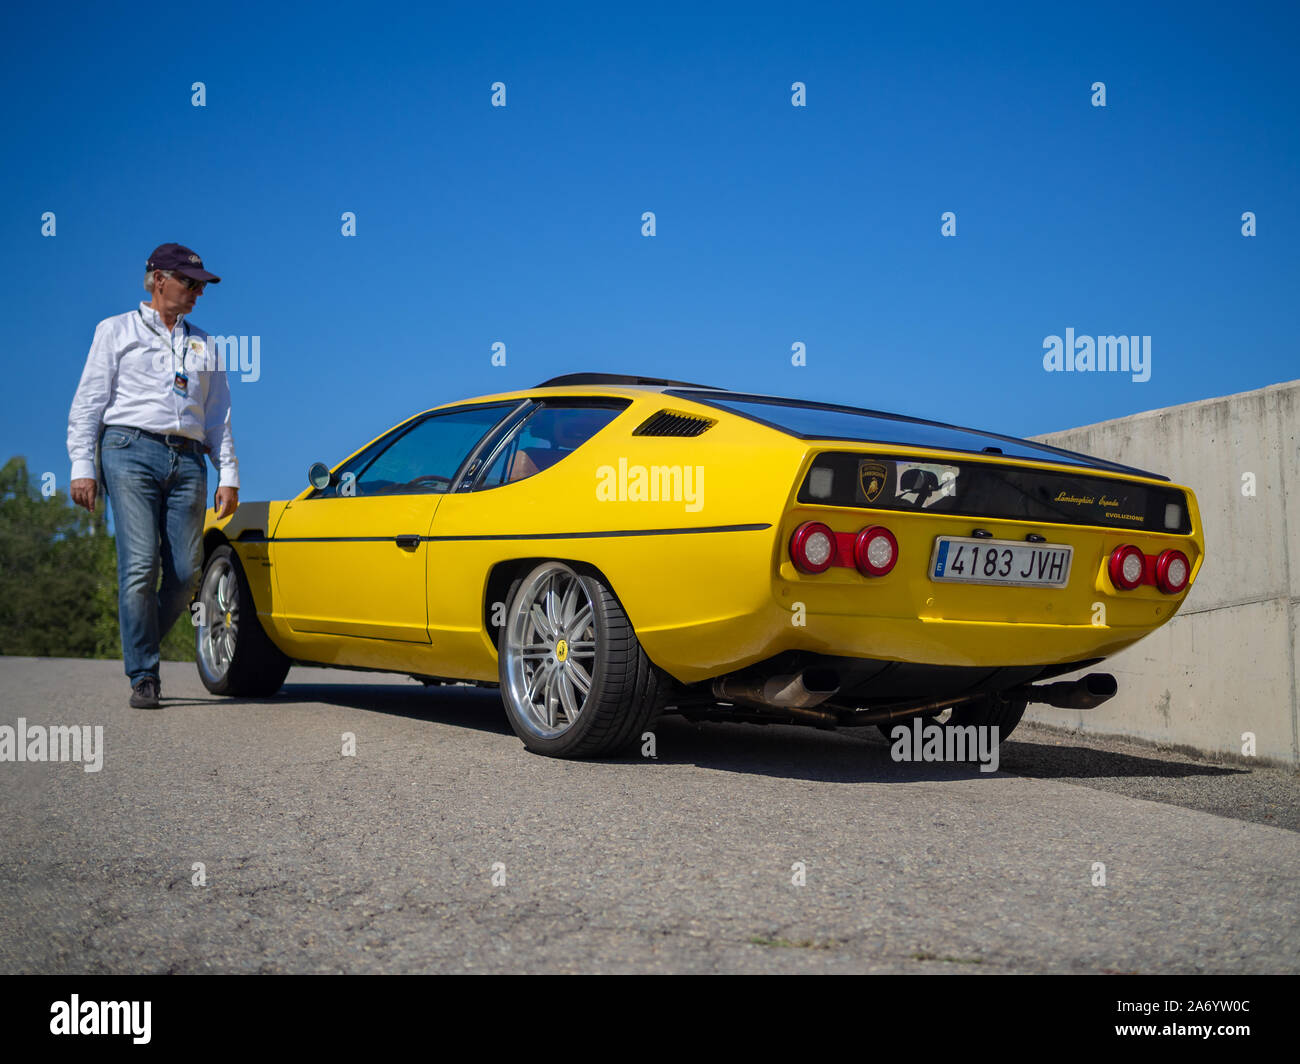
top-left (1026, 380), bottom-right (1300, 764)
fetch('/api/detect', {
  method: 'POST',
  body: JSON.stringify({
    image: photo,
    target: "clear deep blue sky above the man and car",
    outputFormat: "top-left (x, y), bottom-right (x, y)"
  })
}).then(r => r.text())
top-left (0, 3), bottom-right (1300, 499)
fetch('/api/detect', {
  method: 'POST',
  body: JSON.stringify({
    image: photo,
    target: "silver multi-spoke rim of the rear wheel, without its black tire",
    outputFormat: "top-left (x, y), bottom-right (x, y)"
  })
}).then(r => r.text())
top-left (501, 562), bottom-right (597, 739)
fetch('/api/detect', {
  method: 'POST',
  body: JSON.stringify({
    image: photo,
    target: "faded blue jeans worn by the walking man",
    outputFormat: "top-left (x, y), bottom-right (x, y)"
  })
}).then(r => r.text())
top-left (100, 428), bottom-right (208, 685)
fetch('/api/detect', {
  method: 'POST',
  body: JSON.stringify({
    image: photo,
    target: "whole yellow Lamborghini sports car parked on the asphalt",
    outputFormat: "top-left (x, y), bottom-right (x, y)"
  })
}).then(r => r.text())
top-left (196, 373), bottom-right (1204, 757)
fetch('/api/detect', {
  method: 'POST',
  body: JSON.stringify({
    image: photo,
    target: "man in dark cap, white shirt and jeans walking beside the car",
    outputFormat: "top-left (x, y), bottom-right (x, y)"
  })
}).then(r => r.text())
top-left (68, 243), bottom-right (239, 709)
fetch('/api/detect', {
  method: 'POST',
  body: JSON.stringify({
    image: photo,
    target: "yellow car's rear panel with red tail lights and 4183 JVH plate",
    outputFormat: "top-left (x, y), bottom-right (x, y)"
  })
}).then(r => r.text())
top-left (776, 444), bottom-right (1203, 667)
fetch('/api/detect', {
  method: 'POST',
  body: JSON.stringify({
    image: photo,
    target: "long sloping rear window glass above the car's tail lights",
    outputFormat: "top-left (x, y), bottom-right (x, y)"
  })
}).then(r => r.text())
top-left (668, 389), bottom-right (1164, 479)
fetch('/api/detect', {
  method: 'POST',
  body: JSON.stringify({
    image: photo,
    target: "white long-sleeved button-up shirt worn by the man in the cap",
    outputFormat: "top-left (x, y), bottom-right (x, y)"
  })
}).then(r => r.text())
top-left (68, 303), bottom-right (239, 488)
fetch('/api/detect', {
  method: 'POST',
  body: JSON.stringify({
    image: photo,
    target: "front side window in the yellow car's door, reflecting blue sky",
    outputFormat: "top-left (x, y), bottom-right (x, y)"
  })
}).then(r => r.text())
top-left (317, 403), bottom-right (517, 498)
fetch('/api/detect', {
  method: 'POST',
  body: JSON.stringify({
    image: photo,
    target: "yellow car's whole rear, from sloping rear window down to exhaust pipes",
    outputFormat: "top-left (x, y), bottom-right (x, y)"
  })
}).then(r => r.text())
top-left (670, 394), bottom-right (1204, 717)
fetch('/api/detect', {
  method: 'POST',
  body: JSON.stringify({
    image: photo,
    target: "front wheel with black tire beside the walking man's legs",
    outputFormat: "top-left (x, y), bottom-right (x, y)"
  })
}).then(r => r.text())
top-left (195, 545), bottom-right (289, 697)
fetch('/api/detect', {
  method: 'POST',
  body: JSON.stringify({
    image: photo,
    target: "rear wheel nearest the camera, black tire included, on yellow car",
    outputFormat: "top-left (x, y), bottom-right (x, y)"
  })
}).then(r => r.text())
top-left (499, 562), bottom-right (670, 757)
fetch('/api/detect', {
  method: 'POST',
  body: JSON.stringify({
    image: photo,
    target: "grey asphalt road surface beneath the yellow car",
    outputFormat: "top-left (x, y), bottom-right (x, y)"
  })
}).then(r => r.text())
top-left (0, 658), bottom-right (1300, 973)
